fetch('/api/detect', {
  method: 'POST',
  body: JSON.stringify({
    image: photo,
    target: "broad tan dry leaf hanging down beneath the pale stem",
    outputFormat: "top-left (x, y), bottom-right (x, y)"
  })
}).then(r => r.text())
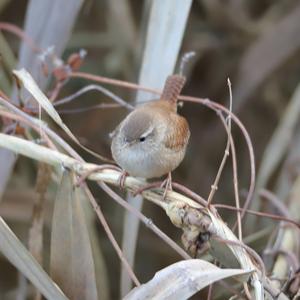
top-left (50, 171), bottom-right (98, 300)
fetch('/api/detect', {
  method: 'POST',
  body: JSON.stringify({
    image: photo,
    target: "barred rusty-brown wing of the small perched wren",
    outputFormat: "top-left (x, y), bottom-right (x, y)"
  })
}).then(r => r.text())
top-left (164, 114), bottom-right (190, 151)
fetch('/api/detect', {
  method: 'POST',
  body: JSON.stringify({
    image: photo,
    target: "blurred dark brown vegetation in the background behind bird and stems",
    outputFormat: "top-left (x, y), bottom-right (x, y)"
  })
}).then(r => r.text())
top-left (0, 0), bottom-right (300, 299)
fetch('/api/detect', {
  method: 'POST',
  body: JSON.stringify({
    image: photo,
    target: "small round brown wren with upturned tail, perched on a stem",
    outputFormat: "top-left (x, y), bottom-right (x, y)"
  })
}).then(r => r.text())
top-left (111, 74), bottom-right (190, 189)
